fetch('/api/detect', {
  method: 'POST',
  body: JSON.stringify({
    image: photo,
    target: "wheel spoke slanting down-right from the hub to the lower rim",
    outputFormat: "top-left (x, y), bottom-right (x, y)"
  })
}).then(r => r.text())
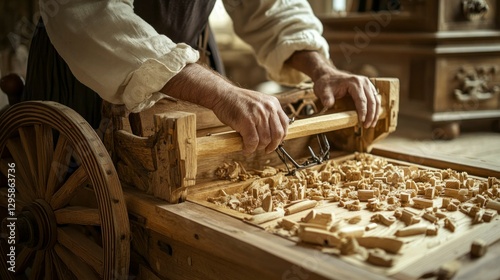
top-left (57, 227), bottom-right (104, 276)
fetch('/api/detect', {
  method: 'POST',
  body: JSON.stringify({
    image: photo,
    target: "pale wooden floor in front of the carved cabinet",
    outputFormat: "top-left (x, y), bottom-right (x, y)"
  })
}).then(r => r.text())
top-left (374, 119), bottom-right (500, 171)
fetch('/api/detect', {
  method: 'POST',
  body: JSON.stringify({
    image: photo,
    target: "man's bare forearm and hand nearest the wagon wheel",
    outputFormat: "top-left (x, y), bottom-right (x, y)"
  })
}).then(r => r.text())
top-left (161, 64), bottom-right (289, 154)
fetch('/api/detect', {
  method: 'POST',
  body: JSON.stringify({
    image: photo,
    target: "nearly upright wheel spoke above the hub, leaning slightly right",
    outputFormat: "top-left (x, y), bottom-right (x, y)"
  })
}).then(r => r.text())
top-left (45, 134), bottom-right (73, 201)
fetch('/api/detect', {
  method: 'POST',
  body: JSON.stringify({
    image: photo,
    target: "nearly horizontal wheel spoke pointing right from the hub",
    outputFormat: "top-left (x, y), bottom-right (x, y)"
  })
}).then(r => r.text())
top-left (54, 206), bottom-right (101, 226)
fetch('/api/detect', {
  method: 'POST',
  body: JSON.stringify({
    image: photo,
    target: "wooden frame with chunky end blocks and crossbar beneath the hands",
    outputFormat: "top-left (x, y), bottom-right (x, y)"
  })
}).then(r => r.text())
top-left (103, 78), bottom-right (399, 203)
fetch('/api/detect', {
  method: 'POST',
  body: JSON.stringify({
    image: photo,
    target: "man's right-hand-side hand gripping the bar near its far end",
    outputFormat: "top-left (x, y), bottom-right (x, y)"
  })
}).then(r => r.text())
top-left (287, 51), bottom-right (381, 128)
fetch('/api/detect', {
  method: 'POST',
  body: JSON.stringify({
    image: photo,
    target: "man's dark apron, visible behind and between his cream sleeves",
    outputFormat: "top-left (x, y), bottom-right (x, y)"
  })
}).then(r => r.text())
top-left (23, 0), bottom-right (219, 128)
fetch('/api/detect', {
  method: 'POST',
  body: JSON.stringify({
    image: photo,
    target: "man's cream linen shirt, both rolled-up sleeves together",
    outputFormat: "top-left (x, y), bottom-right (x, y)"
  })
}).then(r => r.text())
top-left (39, 0), bottom-right (329, 112)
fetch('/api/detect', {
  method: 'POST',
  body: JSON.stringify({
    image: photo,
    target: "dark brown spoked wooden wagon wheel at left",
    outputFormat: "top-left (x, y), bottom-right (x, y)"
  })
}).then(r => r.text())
top-left (0, 101), bottom-right (130, 279)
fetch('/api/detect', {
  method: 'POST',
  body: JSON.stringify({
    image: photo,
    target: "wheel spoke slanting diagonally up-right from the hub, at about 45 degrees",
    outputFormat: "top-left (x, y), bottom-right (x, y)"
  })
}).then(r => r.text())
top-left (50, 166), bottom-right (88, 210)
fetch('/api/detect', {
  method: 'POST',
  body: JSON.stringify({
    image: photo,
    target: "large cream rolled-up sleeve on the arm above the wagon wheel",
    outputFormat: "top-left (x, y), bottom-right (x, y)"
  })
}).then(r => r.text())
top-left (40, 0), bottom-right (199, 112)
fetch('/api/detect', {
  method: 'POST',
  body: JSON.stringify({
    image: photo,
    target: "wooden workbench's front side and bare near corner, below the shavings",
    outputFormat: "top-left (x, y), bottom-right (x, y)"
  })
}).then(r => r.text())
top-left (125, 151), bottom-right (500, 279)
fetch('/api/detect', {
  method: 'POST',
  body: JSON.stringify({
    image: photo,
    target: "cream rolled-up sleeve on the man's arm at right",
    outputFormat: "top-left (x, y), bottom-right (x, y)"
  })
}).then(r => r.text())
top-left (224, 0), bottom-right (329, 85)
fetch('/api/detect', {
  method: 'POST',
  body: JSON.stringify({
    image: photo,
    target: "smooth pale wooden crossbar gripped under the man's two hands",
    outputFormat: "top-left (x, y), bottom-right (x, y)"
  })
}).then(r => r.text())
top-left (196, 111), bottom-right (358, 156)
